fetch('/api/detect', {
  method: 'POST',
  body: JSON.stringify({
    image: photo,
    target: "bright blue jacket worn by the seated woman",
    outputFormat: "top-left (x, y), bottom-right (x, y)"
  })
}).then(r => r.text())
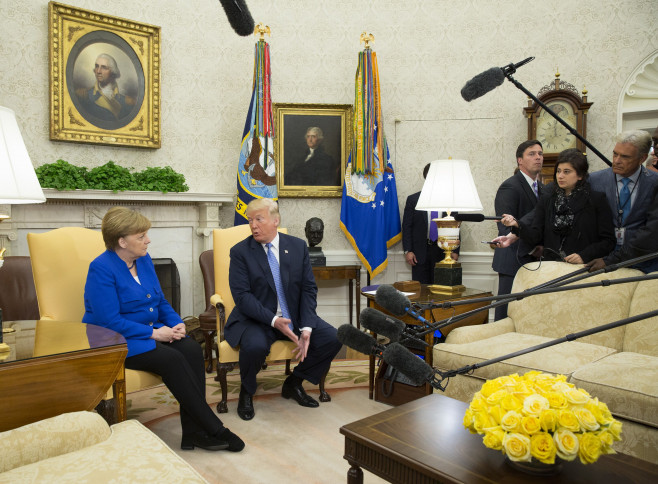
top-left (82, 250), bottom-right (183, 356)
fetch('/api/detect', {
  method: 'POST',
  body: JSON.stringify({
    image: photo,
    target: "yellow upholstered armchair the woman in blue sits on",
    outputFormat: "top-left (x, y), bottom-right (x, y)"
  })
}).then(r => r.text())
top-left (27, 227), bottom-right (162, 421)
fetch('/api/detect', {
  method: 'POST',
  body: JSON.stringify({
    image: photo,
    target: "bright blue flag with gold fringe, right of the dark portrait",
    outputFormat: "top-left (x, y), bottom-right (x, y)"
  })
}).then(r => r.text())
top-left (340, 47), bottom-right (402, 277)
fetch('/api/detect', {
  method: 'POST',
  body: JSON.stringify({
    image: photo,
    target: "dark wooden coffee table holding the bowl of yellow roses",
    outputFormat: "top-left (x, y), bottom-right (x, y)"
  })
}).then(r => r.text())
top-left (340, 394), bottom-right (658, 484)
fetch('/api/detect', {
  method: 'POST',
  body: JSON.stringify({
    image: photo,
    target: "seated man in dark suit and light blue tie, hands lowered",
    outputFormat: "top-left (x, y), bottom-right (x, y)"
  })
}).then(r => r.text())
top-left (224, 198), bottom-right (342, 420)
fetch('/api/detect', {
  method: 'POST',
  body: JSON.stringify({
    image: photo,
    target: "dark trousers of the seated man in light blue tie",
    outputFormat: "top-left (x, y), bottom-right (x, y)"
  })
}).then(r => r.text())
top-left (240, 320), bottom-right (342, 395)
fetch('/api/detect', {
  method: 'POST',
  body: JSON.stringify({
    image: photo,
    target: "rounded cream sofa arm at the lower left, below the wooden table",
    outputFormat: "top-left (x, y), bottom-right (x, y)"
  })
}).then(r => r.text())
top-left (0, 412), bottom-right (112, 472)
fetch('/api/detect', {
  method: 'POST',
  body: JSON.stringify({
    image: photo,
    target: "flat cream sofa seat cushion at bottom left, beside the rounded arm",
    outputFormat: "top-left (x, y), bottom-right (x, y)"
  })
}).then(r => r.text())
top-left (0, 420), bottom-right (207, 484)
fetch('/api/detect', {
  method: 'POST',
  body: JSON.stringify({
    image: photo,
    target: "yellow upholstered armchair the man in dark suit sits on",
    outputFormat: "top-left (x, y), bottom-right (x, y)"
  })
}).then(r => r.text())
top-left (210, 224), bottom-right (331, 413)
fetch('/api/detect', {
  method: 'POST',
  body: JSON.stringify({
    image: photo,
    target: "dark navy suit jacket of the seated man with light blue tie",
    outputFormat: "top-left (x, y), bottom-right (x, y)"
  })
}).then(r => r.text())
top-left (224, 233), bottom-right (321, 347)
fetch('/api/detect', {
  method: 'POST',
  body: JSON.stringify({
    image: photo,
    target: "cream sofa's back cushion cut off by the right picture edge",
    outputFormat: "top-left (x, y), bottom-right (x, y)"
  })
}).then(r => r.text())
top-left (623, 273), bottom-right (658, 357)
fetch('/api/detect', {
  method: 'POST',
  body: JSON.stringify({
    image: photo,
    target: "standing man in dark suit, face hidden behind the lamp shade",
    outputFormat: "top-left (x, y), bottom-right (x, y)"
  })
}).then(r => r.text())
top-left (402, 163), bottom-right (459, 284)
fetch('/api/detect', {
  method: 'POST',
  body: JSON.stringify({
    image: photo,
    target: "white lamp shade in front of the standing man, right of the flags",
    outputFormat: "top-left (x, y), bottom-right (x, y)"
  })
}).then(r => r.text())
top-left (416, 160), bottom-right (482, 212)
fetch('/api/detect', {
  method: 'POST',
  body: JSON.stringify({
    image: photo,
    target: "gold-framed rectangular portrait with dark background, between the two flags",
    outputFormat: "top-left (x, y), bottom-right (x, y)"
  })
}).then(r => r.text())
top-left (273, 103), bottom-right (352, 197)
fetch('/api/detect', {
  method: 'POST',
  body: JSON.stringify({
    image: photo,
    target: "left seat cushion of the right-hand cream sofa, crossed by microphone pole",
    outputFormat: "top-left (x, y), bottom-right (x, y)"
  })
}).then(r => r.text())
top-left (434, 333), bottom-right (615, 379)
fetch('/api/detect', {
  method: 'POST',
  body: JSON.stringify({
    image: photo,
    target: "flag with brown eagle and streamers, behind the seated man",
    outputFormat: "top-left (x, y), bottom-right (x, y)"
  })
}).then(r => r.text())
top-left (233, 40), bottom-right (278, 225)
